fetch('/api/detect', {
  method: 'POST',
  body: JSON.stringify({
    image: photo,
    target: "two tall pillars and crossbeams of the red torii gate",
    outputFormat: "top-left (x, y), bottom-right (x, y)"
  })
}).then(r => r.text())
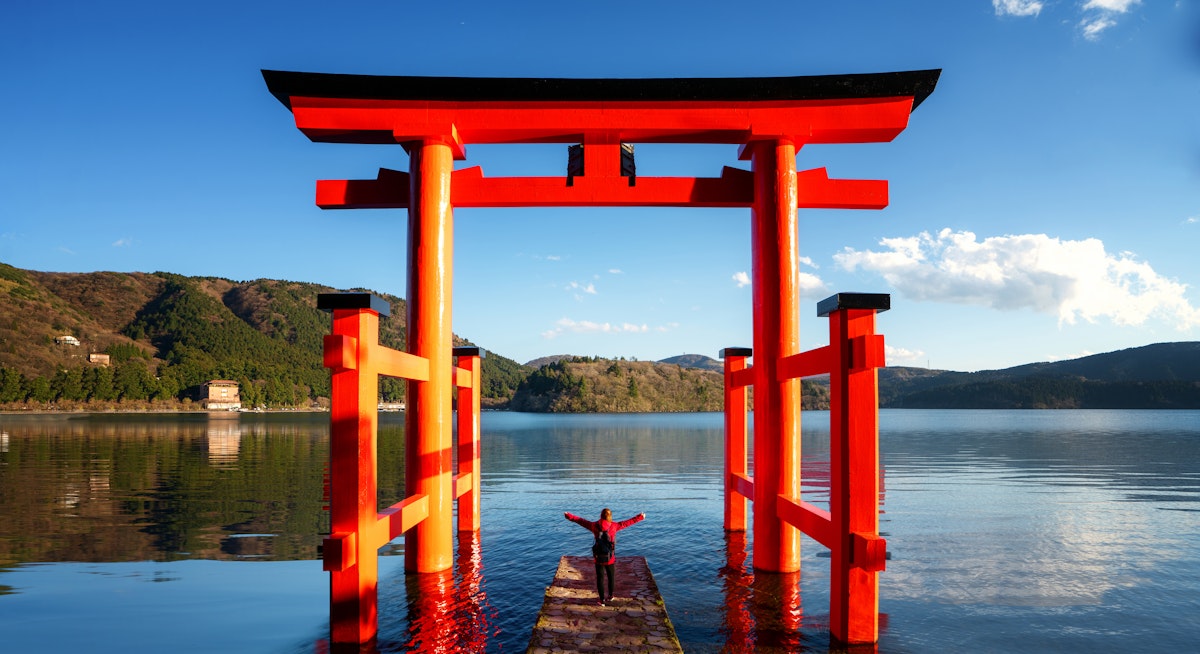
top-left (263, 70), bottom-right (940, 642)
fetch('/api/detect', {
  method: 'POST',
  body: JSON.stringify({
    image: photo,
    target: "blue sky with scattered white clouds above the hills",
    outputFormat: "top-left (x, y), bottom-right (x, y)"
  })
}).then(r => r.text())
top-left (0, 0), bottom-right (1200, 371)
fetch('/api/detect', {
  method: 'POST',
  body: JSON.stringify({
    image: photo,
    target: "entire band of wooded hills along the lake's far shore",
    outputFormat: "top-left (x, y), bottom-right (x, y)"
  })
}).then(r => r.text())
top-left (0, 264), bottom-right (1200, 413)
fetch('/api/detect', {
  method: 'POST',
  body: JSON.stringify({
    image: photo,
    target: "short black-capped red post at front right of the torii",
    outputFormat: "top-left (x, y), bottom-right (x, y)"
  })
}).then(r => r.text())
top-left (817, 293), bottom-right (892, 643)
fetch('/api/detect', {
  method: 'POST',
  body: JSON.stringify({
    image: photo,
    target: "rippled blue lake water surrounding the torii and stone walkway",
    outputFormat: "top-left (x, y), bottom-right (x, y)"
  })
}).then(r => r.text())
top-left (0, 410), bottom-right (1200, 653)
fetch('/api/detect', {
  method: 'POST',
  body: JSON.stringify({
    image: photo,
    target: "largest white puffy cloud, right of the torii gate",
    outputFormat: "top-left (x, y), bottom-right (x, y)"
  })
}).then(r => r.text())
top-left (834, 229), bottom-right (1200, 331)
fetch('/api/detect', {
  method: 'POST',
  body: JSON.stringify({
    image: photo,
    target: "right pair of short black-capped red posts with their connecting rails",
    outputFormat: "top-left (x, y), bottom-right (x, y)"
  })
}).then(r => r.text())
top-left (720, 293), bottom-right (892, 643)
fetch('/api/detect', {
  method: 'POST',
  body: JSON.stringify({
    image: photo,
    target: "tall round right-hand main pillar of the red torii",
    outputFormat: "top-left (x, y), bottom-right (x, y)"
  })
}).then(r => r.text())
top-left (740, 139), bottom-right (800, 572)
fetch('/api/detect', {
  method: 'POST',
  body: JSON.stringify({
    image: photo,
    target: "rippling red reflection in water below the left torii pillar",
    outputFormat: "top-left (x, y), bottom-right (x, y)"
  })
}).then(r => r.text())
top-left (314, 534), bottom-right (497, 654)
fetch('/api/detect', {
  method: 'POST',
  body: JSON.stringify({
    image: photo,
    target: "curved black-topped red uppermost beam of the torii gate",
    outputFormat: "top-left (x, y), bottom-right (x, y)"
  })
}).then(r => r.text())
top-left (263, 70), bottom-right (941, 150)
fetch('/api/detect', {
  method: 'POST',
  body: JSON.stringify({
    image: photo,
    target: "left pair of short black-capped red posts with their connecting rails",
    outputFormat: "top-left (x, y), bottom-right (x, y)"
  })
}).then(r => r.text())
top-left (317, 293), bottom-right (485, 643)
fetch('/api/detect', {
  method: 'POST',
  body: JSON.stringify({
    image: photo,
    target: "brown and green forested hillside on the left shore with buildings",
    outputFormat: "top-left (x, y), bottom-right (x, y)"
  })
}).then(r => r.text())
top-left (0, 264), bottom-right (526, 408)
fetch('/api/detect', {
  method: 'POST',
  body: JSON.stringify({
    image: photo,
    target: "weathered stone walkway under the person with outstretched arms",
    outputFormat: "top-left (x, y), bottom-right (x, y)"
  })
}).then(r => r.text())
top-left (527, 557), bottom-right (683, 654)
